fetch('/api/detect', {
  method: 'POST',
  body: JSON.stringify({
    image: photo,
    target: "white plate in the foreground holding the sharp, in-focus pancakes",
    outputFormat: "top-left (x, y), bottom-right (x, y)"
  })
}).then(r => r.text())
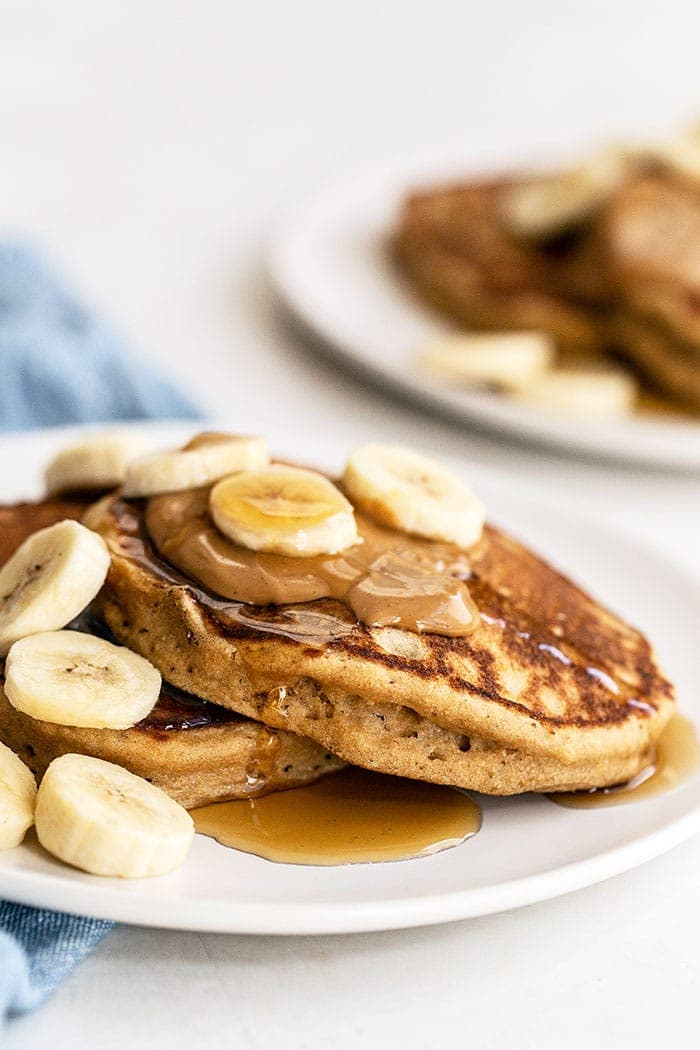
top-left (0, 426), bottom-right (700, 933)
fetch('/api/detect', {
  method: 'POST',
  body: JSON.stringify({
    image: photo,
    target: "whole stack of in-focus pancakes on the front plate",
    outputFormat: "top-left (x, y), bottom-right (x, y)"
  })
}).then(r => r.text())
top-left (0, 438), bottom-right (674, 807)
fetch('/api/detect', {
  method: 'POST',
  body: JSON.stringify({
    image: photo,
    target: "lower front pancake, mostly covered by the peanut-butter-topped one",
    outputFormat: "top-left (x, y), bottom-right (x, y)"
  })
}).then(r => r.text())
top-left (0, 498), bottom-right (344, 809)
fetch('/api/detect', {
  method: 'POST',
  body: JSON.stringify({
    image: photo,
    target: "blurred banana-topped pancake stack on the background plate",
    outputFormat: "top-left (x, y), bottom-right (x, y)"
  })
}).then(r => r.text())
top-left (395, 137), bottom-right (700, 413)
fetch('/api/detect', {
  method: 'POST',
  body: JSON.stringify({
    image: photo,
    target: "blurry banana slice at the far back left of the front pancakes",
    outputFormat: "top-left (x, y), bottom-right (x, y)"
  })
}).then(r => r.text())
top-left (45, 433), bottom-right (144, 496)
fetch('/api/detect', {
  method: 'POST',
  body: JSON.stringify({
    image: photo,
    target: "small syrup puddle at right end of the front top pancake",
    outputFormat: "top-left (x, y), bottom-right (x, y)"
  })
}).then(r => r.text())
top-left (548, 714), bottom-right (700, 810)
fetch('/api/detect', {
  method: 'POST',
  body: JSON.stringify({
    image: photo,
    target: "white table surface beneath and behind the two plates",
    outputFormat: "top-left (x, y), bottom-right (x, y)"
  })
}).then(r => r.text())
top-left (0, 0), bottom-right (700, 1050)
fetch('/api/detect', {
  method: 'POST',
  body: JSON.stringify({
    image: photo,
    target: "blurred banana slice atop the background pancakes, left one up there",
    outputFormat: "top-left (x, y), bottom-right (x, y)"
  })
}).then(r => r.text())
top-left (502, 149), bottom-right (631, 239)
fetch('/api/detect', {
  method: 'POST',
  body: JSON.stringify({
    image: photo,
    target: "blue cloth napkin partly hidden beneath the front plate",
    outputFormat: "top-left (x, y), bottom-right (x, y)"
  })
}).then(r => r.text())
top-left (0, 245), bottom-right (200, 1028)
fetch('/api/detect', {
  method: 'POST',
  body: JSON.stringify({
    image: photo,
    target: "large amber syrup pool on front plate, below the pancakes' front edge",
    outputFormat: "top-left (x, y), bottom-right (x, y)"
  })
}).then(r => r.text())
top-left (192, 768), bottom-right (481, 865)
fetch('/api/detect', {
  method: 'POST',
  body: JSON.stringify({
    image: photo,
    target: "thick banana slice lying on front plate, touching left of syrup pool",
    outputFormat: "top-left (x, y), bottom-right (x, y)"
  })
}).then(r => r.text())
top-left (36, 755), bottom-right (194, 879)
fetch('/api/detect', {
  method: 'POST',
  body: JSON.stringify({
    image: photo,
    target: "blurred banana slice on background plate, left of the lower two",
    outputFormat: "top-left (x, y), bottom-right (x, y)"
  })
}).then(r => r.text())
top-left (421, 332), bottom-right (554, 390)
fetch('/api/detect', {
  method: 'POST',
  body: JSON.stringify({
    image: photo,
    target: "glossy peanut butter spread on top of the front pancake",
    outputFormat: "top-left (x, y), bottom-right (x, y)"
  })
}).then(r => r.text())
top-left (145, 488), bottom-right (480, 637)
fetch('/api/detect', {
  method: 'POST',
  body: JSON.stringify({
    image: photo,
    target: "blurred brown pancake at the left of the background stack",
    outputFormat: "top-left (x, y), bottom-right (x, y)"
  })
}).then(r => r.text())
top-left (395, 180), bottom-right (609, 352)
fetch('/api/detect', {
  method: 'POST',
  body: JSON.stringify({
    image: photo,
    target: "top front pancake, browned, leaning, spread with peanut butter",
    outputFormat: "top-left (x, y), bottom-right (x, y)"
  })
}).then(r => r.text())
top-left (86, 487), bottom-right (674, 794)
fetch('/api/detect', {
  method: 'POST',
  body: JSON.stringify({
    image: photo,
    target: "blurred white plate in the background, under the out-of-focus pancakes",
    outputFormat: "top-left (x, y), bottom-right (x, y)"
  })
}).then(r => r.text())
top-left (270, 154), bottom-right (700, 469)
